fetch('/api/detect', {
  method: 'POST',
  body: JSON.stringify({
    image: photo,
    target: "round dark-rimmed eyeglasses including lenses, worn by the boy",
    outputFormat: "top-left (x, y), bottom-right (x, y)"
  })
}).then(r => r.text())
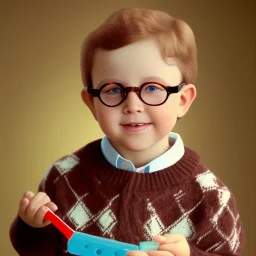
top-left (87, 82), bottom-right (185, 107)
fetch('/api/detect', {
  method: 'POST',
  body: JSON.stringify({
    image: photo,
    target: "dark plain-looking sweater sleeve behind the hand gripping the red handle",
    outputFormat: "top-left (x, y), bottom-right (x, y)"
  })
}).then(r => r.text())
top-left (9, 167), bottom-right (60, 256)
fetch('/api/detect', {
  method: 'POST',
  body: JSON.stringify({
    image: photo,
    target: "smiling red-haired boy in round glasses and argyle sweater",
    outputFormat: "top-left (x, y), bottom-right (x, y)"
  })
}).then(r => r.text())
top-left (10, 8), bottom-right (244, 256)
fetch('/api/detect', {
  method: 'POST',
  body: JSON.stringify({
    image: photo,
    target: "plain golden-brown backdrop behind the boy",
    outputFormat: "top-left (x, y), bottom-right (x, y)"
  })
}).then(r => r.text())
top-left (0, 0), bottom-right (256, 256)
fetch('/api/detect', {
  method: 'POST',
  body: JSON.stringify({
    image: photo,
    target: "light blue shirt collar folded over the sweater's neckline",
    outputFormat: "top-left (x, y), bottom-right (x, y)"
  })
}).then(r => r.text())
top-left (101, 132), bottom-right (185, 173)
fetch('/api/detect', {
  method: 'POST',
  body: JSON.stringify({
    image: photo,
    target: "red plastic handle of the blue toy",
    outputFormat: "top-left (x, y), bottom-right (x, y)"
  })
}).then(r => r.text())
top-left (44, 210), bottom-right (75, 240)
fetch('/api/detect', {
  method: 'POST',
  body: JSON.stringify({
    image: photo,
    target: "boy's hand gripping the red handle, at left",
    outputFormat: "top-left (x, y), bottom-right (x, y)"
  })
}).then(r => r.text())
top-left (18, 191), bottom-right (58, 228)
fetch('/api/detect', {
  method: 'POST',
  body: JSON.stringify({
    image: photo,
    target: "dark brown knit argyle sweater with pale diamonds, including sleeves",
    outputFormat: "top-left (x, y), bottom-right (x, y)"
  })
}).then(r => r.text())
top-left (10, 140), bottom-right (244, 256)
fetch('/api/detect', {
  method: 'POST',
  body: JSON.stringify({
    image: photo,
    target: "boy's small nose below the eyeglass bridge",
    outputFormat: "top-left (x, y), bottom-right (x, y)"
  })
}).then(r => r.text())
top-left (123, 91), bottom-right (145, 114)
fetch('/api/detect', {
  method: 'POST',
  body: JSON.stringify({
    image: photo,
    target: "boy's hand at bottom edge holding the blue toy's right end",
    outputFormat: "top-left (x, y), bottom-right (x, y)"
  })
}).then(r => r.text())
top-left (127, 234), bottom-right (190, 256)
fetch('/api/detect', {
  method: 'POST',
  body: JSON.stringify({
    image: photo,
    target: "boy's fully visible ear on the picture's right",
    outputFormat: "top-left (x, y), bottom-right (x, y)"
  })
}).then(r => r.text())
top-left (177, 84), bottom-right (196, 118)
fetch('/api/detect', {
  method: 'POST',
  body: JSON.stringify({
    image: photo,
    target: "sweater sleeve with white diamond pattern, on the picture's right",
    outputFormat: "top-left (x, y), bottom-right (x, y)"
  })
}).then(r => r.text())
top-left (189, 171), bottom-right (245, 256)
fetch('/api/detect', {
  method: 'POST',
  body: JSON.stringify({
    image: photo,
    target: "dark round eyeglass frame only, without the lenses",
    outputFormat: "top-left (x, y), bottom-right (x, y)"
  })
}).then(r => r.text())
top-left (87, 82), bottom-right (185, 107)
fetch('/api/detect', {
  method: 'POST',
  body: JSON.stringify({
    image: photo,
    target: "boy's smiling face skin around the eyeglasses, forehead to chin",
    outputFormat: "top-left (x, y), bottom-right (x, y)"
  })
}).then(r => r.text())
top-left (83, 39), bottom-right (195, 161)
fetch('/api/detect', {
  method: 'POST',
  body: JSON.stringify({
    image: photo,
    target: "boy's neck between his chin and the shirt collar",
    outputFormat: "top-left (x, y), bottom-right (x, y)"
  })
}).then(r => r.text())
top-left (110, 135), bottom-right (173, 168)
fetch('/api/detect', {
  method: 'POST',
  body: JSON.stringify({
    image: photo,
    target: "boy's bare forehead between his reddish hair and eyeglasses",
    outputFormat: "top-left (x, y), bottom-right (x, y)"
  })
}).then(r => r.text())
top-left (92, 39), bottom-right (182, 86)
